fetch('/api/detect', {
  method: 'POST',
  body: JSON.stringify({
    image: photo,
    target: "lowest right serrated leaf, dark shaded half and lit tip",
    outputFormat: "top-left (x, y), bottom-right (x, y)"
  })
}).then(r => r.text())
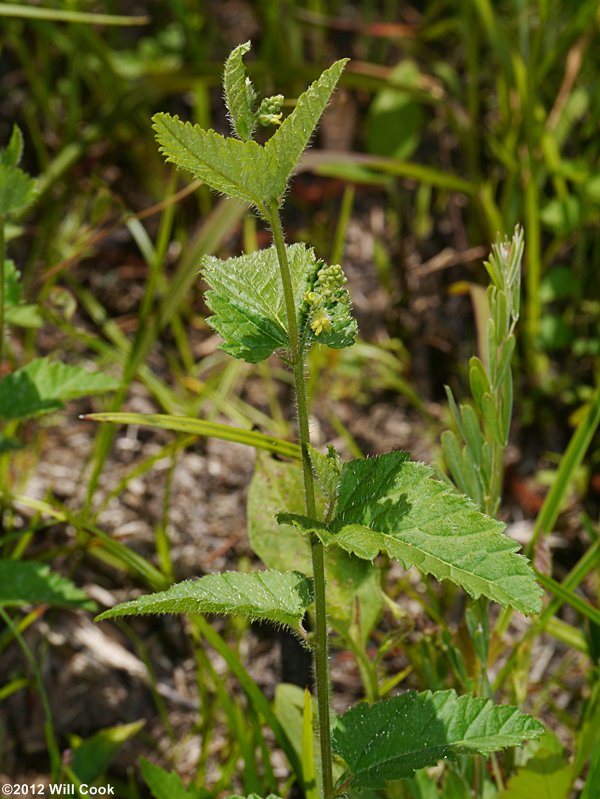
top-left (333, 691), bottom-right (544, 788)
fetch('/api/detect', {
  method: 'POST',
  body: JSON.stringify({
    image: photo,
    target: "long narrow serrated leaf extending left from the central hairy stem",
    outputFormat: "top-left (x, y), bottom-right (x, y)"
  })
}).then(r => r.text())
top-left (96, 569), bottom-right (313, 629)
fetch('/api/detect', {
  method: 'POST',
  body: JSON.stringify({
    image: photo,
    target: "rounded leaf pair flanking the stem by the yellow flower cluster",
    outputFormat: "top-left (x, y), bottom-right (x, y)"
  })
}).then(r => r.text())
top-left (202, 244), bottom-right (356, 363)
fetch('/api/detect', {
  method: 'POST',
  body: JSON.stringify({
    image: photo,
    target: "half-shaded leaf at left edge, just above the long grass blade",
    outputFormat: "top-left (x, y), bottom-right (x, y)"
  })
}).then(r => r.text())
top-left (0, 358), bottom-right (119, 419)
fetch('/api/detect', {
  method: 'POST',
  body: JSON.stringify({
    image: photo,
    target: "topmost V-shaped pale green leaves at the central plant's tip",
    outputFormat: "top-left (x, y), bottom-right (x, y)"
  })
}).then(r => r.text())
top-left (153, 45), bottom-right (346, 209)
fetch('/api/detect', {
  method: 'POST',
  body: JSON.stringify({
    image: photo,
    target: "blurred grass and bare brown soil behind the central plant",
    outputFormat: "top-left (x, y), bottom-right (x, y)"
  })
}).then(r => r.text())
top-left (0, 0), bottom-right (600, 799)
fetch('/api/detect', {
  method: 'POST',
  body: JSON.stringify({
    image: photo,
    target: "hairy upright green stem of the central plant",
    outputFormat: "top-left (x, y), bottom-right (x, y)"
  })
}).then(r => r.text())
top-left (266, 204), bottom-right (334, 799)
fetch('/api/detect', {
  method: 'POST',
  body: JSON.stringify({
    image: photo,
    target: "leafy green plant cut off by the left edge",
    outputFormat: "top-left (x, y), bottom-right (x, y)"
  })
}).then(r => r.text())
top-left (0, 126), bottom-right (118, 780)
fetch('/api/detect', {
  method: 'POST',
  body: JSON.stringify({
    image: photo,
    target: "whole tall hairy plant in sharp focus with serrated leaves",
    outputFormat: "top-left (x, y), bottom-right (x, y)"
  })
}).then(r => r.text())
top-left (92, 43), bottom-right (543, 799)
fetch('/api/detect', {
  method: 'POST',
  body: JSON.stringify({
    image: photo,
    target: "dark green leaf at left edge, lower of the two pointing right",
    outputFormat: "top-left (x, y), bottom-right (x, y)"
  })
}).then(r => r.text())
top-left (0, 560), bottom-right (96, 610)
